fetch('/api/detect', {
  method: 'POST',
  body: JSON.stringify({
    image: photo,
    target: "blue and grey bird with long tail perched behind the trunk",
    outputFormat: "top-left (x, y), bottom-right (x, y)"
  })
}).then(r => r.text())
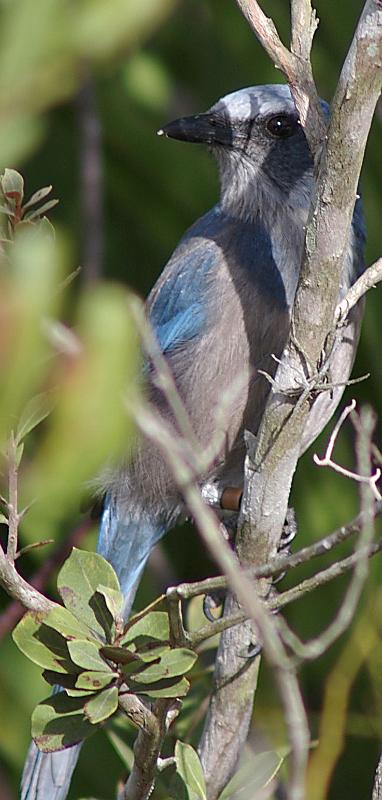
top-left (21, 84), bottom-right (365, 800)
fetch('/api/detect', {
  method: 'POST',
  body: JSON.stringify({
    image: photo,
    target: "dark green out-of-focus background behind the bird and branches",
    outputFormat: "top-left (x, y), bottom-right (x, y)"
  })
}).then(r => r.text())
top-left (0, 0), bottom-right (382, 800)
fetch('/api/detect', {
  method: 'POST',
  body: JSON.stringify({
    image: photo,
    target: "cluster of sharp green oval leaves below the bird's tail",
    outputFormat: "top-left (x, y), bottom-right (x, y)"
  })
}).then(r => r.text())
top-left (13, 548), bottom-right (196, 752)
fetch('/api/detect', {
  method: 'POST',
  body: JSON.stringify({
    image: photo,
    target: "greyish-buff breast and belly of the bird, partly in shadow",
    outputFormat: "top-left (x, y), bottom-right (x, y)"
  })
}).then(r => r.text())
top-left (163, 219), bottom-right (292, 451)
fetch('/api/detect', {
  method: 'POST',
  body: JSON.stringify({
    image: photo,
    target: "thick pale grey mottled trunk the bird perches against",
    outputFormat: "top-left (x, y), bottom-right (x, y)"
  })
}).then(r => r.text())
top-left (197, 0), bottom-right (382, 800)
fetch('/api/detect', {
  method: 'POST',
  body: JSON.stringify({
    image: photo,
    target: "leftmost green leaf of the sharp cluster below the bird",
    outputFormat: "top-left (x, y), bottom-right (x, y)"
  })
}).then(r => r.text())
top-left (12, 611), bottom-right (79, 673)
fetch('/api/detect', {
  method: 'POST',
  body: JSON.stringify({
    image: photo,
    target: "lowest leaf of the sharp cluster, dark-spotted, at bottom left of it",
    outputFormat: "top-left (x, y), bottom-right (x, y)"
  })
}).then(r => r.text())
top-left (32, 692), bottom-right (95, 753)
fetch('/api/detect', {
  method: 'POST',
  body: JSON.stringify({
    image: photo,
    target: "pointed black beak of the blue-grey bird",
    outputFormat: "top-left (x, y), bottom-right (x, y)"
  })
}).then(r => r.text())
top-left (158, 111), bottom-right (233, 147)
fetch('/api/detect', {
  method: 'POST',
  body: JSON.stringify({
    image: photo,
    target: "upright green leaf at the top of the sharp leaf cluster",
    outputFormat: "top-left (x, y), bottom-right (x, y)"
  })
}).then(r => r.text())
top-left (57, 547), bottom-right (120, 641)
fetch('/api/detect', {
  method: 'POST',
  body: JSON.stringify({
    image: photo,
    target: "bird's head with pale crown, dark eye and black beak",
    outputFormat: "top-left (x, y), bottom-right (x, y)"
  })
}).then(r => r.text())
top-left (159, 84), bottom-right (320, 216)
